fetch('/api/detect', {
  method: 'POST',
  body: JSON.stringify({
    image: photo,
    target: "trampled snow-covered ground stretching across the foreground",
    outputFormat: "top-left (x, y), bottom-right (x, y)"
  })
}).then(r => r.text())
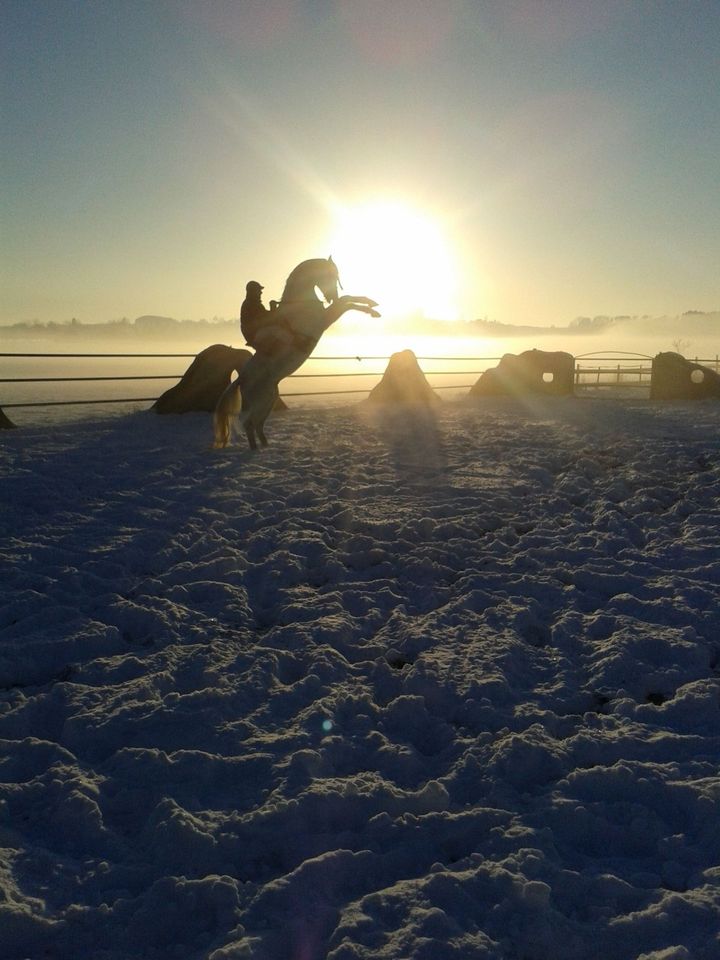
top-left (0, 399), bottom-right (720, 960)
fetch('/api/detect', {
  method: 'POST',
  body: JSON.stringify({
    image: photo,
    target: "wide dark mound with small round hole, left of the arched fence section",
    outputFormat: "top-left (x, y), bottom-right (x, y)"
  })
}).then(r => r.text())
top-left (470, 350), bottom-right (575, 397)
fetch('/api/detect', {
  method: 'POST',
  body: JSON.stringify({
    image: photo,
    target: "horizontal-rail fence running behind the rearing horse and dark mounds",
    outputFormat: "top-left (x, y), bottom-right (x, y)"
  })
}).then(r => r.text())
top-left (0, 350), bottom-right (720, 409)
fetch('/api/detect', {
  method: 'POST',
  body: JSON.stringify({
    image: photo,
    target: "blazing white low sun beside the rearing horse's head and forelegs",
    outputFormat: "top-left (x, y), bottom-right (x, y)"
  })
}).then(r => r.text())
top-left (330, 200), bottom-right (458, 321)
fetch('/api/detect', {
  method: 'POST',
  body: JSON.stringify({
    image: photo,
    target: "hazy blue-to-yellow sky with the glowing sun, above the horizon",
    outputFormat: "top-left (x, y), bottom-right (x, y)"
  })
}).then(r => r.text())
top-left (0, 0), bottom-right (720, 324)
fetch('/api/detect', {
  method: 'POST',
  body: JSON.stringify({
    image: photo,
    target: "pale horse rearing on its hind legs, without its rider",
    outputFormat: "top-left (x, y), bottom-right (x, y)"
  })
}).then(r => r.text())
top-left (213, 257), bottom-right (380, 450)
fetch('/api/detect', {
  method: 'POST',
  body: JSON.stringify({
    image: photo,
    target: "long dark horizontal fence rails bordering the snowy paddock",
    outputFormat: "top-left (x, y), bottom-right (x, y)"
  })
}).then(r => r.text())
top-left (0, 350), bottom-right (720, 409)
